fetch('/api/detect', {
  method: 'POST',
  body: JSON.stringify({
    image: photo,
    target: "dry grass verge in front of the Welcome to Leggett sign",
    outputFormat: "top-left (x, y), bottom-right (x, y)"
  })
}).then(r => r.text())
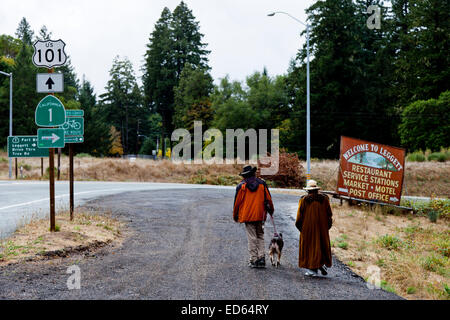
top-left (330, 204), bottom-right (450, 299)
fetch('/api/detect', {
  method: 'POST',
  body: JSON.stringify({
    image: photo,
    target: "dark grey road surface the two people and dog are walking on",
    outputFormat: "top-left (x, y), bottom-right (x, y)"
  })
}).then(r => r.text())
top-left (0, 188), bottom-right (399, 299)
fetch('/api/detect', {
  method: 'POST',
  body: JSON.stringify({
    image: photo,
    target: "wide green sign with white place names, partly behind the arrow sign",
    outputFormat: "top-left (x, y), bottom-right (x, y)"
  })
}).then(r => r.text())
top-left (8, 136), bottom-right (48, 158)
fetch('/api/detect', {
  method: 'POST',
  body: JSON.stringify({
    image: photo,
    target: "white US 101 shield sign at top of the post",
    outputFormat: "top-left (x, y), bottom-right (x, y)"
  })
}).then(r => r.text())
top-left (33, 39), bottom-right (67, 69)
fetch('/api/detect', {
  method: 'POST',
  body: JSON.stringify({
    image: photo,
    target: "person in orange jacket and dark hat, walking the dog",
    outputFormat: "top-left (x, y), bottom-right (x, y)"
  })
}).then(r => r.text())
top-left (233, 166), bottom-right (274, 268)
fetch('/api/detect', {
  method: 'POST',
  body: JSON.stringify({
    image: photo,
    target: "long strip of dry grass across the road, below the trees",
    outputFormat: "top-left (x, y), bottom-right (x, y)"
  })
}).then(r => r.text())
top-left (0, 152), bottom-right (450, 197)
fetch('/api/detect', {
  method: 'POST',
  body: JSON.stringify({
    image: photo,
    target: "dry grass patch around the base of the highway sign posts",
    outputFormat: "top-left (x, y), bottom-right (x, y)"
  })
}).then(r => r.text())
top-left (0, 211), bottom-right (123, 265)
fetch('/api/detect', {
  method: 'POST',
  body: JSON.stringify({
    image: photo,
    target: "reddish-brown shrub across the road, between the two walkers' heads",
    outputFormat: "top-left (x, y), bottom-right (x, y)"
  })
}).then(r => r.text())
top-left (257, 150), bottom-right (306, 188)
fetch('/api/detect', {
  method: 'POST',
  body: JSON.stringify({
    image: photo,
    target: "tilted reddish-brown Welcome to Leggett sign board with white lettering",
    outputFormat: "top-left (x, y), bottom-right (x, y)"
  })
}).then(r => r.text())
top-left (337, 136), bottom-right (405, 205)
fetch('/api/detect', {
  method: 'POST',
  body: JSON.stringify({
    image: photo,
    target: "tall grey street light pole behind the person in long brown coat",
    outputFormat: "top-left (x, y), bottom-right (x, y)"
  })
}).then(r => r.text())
top-left (268, 11), bottom-right (311, 181)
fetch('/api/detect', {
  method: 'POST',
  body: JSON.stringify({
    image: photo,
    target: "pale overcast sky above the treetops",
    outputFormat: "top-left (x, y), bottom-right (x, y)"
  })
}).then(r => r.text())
top-left (0, 0), bottom-right (315, 94)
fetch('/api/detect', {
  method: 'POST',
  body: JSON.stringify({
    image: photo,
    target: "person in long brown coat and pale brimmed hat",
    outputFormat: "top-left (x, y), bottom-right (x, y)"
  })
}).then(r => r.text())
top-left (295, 180), bottom-right (332, 276)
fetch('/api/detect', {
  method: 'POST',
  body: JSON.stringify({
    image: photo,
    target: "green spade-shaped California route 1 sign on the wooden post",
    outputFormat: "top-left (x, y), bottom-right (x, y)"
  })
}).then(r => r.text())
top-left (35, 95), bottom-right (66, 127)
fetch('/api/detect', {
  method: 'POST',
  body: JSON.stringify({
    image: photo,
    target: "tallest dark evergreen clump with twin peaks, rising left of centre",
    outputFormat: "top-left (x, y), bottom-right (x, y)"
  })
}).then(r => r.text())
top-left (143, 1), bottom-right (209, 139)
